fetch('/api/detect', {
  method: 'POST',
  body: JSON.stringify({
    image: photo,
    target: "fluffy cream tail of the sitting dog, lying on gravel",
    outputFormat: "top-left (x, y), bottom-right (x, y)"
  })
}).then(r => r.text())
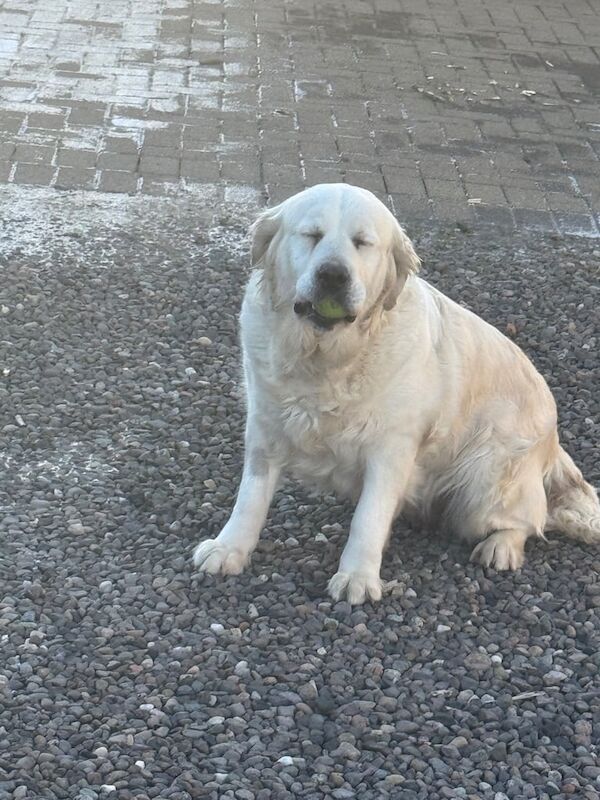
top-left (544, 447), bottom-right (600, 544)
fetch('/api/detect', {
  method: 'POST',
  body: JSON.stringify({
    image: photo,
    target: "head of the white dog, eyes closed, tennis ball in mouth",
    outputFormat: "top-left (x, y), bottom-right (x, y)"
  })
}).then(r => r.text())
top-left (252, 184), bottom-right (420, 331)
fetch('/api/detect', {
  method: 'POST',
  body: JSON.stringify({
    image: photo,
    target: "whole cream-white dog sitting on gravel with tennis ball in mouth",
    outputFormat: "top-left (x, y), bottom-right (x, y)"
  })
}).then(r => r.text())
top-left (194, 184), bottom-right (600, 603)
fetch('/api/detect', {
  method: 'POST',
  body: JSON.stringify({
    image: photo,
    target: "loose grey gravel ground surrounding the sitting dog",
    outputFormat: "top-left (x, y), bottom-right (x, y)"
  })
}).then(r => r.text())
top-left (0, 188), bottom-right (600, 800)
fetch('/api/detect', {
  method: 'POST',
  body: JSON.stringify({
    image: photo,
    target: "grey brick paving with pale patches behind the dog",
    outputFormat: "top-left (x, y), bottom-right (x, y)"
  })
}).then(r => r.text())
top-left (0, 0), bottom-right (600, 235)
